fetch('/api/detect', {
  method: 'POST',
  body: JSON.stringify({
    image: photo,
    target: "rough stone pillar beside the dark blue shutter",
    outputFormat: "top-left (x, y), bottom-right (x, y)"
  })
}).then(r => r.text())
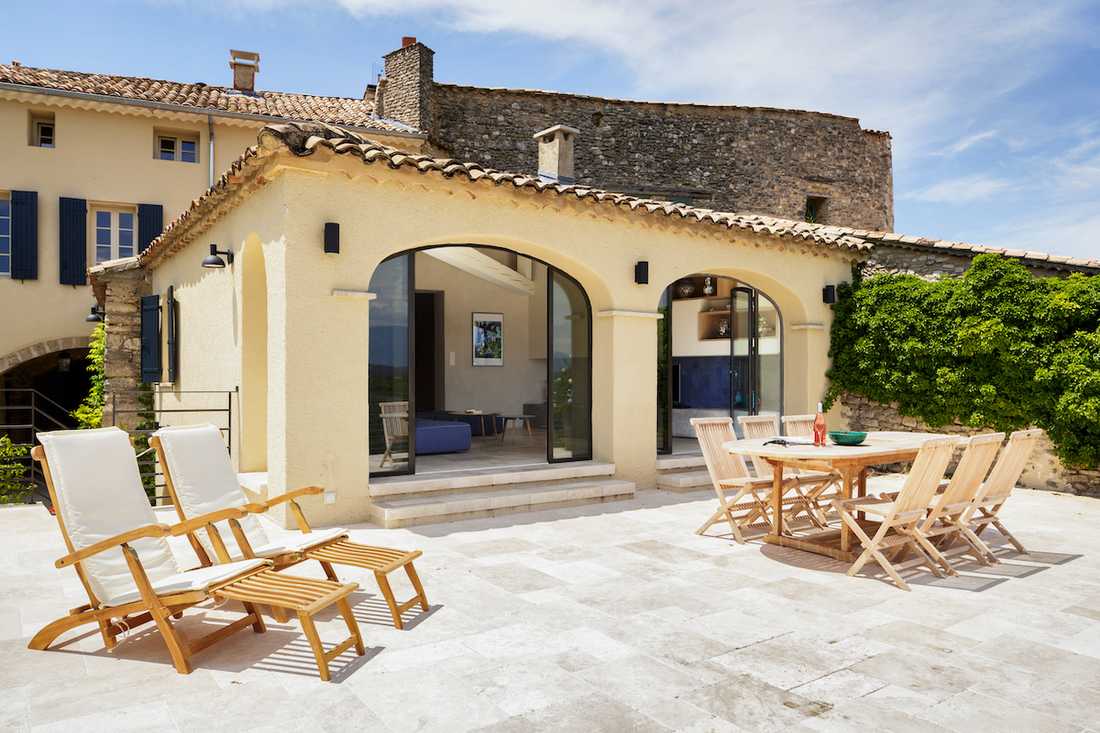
top-left (92, 262), bottom-right (149, 430)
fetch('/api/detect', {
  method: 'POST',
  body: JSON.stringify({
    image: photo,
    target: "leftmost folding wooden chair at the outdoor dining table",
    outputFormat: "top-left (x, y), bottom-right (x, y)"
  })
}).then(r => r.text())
top-left (691, 417), bottom-right (771, 544)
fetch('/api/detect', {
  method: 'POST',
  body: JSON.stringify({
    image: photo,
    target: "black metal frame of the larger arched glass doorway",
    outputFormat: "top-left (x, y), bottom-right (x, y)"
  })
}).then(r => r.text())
top-left (367, 242), bottom-right (595, 478)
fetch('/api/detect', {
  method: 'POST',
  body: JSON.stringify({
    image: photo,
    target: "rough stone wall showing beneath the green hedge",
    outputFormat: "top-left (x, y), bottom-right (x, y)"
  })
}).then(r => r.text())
top-left (840, 394), bottom-right (1100, 496)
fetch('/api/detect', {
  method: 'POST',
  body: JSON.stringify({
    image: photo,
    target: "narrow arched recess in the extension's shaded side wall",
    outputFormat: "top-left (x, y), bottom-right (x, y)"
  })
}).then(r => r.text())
top-left (240, 236), bottom-right (267, 472)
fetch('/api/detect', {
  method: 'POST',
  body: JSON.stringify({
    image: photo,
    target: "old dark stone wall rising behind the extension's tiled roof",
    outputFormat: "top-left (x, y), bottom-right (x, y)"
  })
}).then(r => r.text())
top-left (429, 80), bottom-right (893, 231)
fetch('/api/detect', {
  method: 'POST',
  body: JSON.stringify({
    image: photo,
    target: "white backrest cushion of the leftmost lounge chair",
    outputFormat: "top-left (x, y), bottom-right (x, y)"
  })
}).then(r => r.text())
top-left (39, 427), bottom-right (180, 602)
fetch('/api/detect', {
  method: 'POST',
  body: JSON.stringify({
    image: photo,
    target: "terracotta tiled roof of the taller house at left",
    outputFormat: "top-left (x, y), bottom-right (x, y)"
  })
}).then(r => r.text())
top-left (0, 64), bottom-right (416, 132)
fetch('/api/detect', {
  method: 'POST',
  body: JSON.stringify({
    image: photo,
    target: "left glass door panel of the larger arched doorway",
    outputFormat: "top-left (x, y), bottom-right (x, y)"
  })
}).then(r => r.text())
top-left (367, 254), bottom-right (416, 475)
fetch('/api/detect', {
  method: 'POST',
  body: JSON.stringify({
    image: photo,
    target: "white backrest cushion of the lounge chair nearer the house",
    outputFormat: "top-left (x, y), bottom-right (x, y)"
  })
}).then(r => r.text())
top-left (154, 425), bottom-right (272, 560)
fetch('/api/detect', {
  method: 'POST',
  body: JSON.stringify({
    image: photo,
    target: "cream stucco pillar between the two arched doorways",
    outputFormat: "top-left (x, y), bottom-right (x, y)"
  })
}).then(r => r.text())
top-left (593, 310), bottom-right (661, 489)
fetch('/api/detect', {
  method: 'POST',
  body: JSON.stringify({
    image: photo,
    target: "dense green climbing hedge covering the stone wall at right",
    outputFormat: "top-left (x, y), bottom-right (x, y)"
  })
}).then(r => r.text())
top-left (826, 254), bottom-right (1100, 466)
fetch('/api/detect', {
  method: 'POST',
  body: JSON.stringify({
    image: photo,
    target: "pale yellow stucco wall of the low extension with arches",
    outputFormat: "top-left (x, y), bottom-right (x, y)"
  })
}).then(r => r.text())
top-left (153, 150), bottom-right (850, 524)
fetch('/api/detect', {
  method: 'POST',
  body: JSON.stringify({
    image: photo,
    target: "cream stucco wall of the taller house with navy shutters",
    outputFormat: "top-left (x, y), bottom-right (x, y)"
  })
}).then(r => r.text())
top-left (0, 91), bottom-right (419, 374)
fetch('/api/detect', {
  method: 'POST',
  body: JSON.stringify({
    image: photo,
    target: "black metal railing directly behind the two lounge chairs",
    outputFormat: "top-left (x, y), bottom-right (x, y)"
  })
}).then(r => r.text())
top-left (103, 389), bottom-right (237, 504)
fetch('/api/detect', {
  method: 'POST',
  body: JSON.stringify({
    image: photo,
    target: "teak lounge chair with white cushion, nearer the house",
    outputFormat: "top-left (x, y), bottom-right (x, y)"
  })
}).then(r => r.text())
top-left (150, 425), bottom-right (428, 628)
